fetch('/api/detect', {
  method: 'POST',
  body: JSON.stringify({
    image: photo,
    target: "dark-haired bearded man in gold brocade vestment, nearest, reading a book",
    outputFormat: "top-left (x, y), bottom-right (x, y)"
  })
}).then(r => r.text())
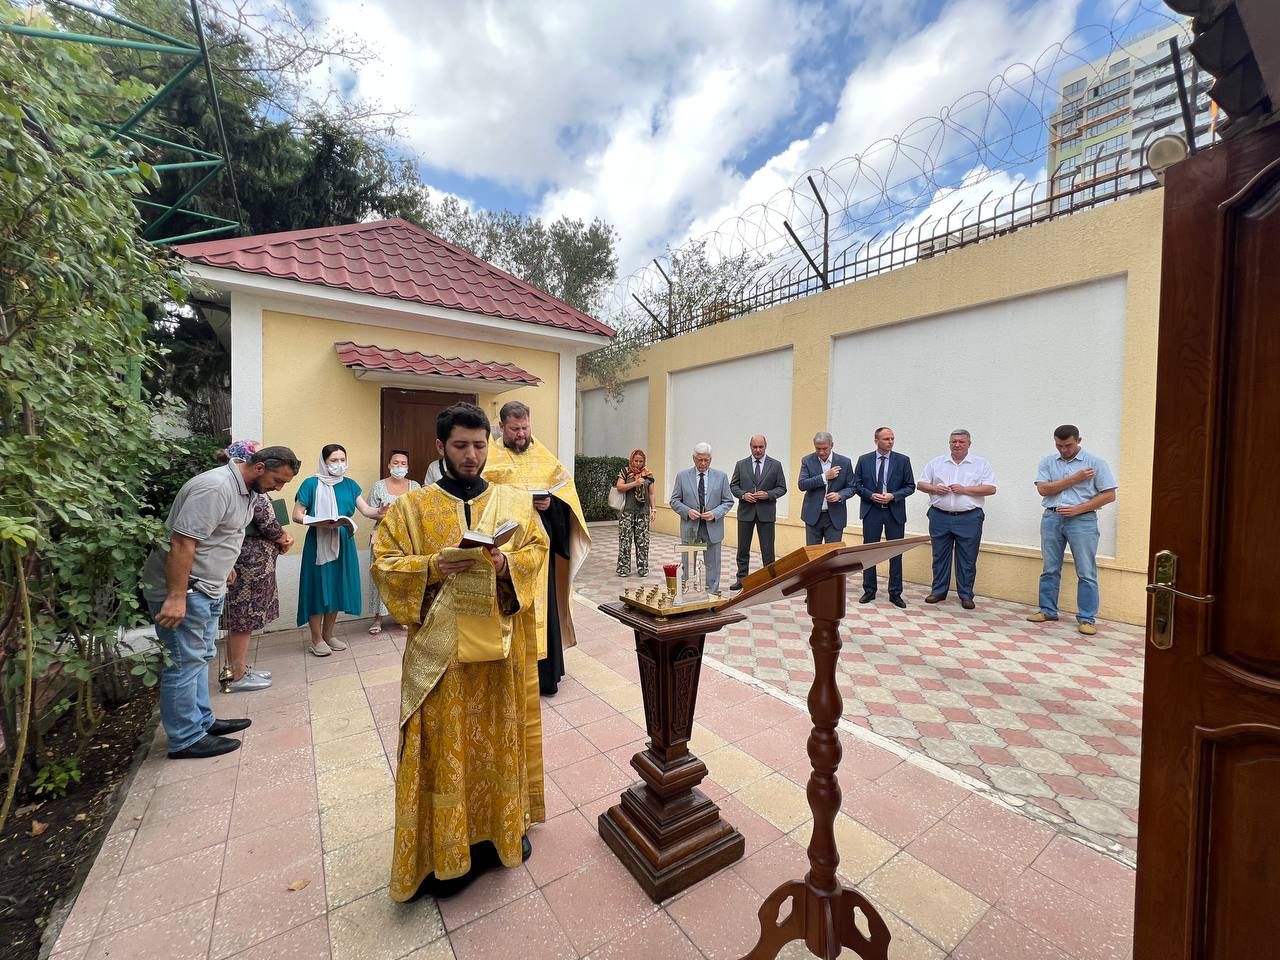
top-left (372, 403), bottom-right (547, 901)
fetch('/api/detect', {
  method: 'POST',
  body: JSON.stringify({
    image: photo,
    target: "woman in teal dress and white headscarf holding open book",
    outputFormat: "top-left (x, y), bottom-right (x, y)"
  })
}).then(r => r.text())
top-left (293, 443), bottom-right (385, 657)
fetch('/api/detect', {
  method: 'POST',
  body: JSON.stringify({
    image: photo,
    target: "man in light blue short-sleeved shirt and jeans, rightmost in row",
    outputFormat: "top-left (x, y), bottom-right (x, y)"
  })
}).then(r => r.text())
top-left (1027, 424), bottom-right (1116, 636)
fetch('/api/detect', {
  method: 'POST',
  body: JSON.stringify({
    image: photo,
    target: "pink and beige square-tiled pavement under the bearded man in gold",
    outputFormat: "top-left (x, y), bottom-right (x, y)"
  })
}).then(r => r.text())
top-left (45, 603), bottom-right (1134, 960)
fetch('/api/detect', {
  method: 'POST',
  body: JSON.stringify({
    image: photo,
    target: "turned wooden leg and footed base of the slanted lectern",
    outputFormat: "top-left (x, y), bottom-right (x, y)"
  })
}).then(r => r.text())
top-left (744, 577), bottom-right (890, 960)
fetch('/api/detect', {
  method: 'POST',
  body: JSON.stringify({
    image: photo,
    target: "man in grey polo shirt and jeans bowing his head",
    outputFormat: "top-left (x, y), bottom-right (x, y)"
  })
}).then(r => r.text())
top-left (142, 447), bottom-right (302, 760)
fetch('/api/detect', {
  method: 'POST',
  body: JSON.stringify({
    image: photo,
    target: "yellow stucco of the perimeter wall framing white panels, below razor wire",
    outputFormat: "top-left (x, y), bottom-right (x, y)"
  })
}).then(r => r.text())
top-left (579, 189), bottom-right (1164, 623)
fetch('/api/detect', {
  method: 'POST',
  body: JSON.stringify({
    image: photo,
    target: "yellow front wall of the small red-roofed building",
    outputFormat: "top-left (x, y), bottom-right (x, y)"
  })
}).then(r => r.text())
top-left (262, 310), bottom-right (560, 544)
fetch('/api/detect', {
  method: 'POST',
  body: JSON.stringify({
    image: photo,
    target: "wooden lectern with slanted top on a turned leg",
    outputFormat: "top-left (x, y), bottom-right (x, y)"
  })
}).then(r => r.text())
top-left (717, 536), bottom-right (929, 960)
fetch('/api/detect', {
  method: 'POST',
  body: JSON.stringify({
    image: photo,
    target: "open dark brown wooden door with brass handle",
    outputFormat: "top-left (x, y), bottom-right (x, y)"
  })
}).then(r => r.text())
top-left (1134, 127), bottom-right (1280, 960)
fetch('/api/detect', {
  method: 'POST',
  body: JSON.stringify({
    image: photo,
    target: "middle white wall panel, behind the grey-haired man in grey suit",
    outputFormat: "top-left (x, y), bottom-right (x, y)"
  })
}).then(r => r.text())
top-left (662, 347), bottom-right (799, 517)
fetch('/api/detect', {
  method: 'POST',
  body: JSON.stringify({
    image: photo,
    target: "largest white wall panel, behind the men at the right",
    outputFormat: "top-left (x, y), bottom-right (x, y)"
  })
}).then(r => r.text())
top-left (829, 276), bottom-right (1125, 557)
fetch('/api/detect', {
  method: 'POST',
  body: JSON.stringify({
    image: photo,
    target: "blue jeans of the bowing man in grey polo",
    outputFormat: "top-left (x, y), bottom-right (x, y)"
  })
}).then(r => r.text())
top-left (147, 590), bottom-right (223, 753)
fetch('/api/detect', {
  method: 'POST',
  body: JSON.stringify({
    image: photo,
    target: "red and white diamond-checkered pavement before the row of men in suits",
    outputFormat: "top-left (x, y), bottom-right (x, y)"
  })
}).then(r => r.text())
top-left (577, 524), bottom-right (1143, 863)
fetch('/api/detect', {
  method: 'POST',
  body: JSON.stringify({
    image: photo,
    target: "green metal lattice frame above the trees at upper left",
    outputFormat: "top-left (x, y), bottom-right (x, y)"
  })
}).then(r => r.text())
top-left (0, 0), bottom-right (241, 246)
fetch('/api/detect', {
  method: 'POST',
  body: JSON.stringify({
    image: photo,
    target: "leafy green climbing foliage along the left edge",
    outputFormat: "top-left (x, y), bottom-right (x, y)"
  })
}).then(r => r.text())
top-left (0, 4), bottom-right (187, 823)
